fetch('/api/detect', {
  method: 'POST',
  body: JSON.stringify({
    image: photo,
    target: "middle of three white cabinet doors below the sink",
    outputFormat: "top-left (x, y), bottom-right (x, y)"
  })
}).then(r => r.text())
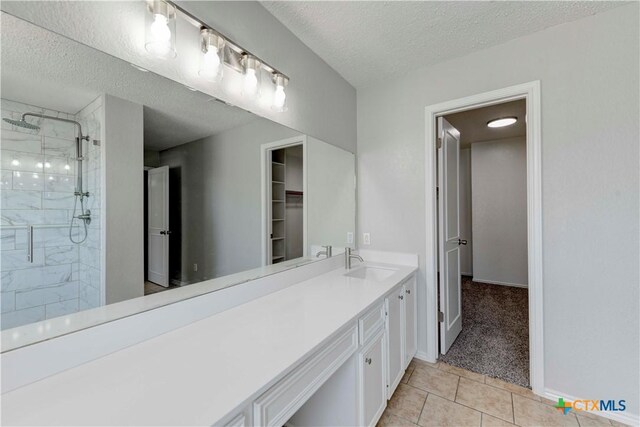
top-left (387, 292), bottom-right (405, 399)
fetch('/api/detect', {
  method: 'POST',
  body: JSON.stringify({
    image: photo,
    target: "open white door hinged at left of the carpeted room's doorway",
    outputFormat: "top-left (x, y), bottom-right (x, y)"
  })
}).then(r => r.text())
top-left (438, 117), bottom-right (466, 354)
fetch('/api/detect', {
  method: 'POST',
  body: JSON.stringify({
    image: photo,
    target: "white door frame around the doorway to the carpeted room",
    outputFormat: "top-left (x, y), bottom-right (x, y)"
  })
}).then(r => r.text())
top-left (425, 80), bottom-right (544, 394)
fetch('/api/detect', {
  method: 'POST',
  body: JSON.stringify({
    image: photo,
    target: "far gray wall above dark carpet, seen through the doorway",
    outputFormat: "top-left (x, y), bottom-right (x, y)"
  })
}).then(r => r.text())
top-left (471, 137), bottom-right (529, 286)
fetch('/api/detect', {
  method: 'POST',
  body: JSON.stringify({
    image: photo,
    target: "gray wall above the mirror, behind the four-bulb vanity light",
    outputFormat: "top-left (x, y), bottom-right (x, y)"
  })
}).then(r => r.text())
top-left (2, 1), bottom-right (356, 152)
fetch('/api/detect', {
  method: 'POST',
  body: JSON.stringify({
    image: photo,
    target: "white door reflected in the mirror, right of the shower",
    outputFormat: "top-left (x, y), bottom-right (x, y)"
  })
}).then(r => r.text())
top-left (147, 166), bottom-right (170, 287)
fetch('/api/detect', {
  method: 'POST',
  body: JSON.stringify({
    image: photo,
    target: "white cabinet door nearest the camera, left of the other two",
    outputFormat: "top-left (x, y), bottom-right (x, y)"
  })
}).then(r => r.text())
top-left (360, 329), bottom-right (387, 426)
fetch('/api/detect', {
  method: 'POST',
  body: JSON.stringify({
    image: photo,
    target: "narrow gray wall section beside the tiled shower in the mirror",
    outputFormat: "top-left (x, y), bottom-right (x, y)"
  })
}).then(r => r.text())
top-left (104, 95), bottom-right (145, 304)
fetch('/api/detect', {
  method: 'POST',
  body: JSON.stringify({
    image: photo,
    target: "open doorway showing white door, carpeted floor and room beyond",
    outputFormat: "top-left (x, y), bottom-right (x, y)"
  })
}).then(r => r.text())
top-left (437, 99), bottom-right (529, 387)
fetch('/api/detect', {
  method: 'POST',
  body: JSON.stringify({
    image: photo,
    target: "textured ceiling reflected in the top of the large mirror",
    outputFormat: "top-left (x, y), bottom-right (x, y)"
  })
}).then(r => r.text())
top-left (0, 13), bottom-right (261, 150)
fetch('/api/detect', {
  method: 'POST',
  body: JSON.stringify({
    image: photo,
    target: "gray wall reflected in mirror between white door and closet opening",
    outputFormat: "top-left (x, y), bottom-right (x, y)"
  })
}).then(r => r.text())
top-left (160, 119), bottom-right (299, 283)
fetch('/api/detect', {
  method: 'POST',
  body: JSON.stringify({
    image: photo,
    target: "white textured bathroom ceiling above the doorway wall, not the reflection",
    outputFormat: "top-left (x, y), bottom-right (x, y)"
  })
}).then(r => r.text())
top-left (262, 1), bottom-right (624, 89)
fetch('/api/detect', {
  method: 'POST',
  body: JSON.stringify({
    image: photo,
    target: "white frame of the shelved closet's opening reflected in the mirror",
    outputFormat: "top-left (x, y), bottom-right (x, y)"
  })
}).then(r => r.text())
top-left (260, 135), bottom-right (309, 267)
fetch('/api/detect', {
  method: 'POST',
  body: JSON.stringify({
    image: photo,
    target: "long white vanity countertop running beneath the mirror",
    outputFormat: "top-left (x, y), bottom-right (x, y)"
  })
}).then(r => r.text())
top-left (2, 263), bottom-right (416, 425)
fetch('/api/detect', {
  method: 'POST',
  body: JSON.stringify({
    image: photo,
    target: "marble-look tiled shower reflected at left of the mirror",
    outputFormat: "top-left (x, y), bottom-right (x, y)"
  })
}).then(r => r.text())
top-left (0, 97), bottom-right (104, 329)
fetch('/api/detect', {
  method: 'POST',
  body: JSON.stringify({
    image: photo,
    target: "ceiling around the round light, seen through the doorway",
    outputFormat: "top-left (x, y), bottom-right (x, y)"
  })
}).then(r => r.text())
top-left (445, 99), bottom-right (527, 148)
